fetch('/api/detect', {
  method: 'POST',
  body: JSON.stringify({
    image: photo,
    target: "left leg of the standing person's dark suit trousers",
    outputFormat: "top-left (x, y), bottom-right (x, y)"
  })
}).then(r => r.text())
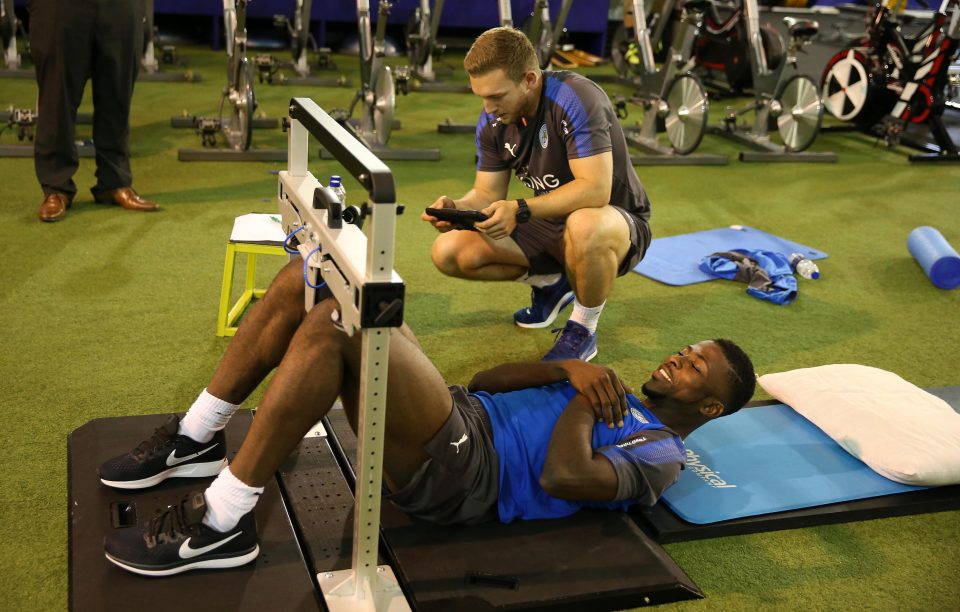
top-left (27, 0), bottom-right (96, 198)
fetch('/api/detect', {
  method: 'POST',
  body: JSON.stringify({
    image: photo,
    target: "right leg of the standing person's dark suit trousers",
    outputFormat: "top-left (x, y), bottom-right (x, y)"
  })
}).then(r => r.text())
top-left (92, 0), bottom-right (144, 195)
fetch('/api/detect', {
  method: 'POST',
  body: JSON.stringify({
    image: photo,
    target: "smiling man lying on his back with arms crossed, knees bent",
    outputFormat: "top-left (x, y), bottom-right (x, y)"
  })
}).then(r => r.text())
top-left (100, 262), bottom-right (755, 576)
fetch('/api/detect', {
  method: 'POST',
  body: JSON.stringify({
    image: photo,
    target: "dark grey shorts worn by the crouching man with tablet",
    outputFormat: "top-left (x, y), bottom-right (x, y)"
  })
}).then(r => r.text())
top-left (510, 206), bottom-right (652, 276)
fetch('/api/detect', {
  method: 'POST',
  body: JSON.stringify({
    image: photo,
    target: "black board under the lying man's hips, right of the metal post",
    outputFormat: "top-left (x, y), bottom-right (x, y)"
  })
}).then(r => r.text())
top-left (318, 410), bottom-right (703, 612)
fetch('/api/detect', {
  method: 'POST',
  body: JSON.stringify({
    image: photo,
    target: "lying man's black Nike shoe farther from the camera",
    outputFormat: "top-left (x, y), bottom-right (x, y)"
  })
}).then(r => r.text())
top-left (100, 415), bottom-right (227, 489)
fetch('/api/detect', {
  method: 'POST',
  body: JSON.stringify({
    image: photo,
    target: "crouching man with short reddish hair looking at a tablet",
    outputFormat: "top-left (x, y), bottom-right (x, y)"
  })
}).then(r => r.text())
top-left (423, 27), bottom-right (651, 361)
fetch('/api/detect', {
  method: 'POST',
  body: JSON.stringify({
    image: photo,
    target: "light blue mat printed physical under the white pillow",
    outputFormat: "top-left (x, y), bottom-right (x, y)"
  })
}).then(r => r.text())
top-left (662, 404), bottom-right (926, 525)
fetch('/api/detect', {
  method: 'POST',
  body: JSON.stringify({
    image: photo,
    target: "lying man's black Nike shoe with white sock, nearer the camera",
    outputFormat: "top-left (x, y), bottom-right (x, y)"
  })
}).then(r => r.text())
top-left (103, 491), bottom-right (260, 576)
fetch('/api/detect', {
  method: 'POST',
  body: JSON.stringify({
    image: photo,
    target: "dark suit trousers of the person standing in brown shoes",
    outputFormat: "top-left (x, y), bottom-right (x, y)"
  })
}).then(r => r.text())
top-left (27, 0), bottom-right (144, 198)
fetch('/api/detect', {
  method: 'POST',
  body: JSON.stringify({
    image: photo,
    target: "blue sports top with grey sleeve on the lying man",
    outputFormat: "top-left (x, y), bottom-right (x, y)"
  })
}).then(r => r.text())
top-left (473, 382), bottom-right (686, 523)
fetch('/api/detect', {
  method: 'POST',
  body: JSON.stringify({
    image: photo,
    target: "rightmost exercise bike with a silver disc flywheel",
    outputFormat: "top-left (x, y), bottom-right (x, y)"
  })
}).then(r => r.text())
top-left (694, 0), bottom-right (837, 162)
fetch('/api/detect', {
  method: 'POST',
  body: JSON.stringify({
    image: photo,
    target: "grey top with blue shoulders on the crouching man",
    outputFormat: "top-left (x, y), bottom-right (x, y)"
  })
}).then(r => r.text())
top-left (476, 70), bottom-right (650, 219)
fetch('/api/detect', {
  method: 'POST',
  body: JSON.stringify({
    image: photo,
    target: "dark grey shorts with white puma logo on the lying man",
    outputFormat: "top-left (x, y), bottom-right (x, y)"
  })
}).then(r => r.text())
top-left (385, 385), bottom-right (500, 525)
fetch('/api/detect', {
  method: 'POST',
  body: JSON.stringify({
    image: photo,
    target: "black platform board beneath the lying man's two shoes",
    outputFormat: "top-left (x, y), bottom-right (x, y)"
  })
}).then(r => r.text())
top-left (67, 410), bottom-right (319, 612)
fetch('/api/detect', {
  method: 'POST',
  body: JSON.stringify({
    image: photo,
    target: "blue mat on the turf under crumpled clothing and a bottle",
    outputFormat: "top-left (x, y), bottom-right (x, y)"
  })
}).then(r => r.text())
top-left (633, 225), bottom-right (827, 285)
